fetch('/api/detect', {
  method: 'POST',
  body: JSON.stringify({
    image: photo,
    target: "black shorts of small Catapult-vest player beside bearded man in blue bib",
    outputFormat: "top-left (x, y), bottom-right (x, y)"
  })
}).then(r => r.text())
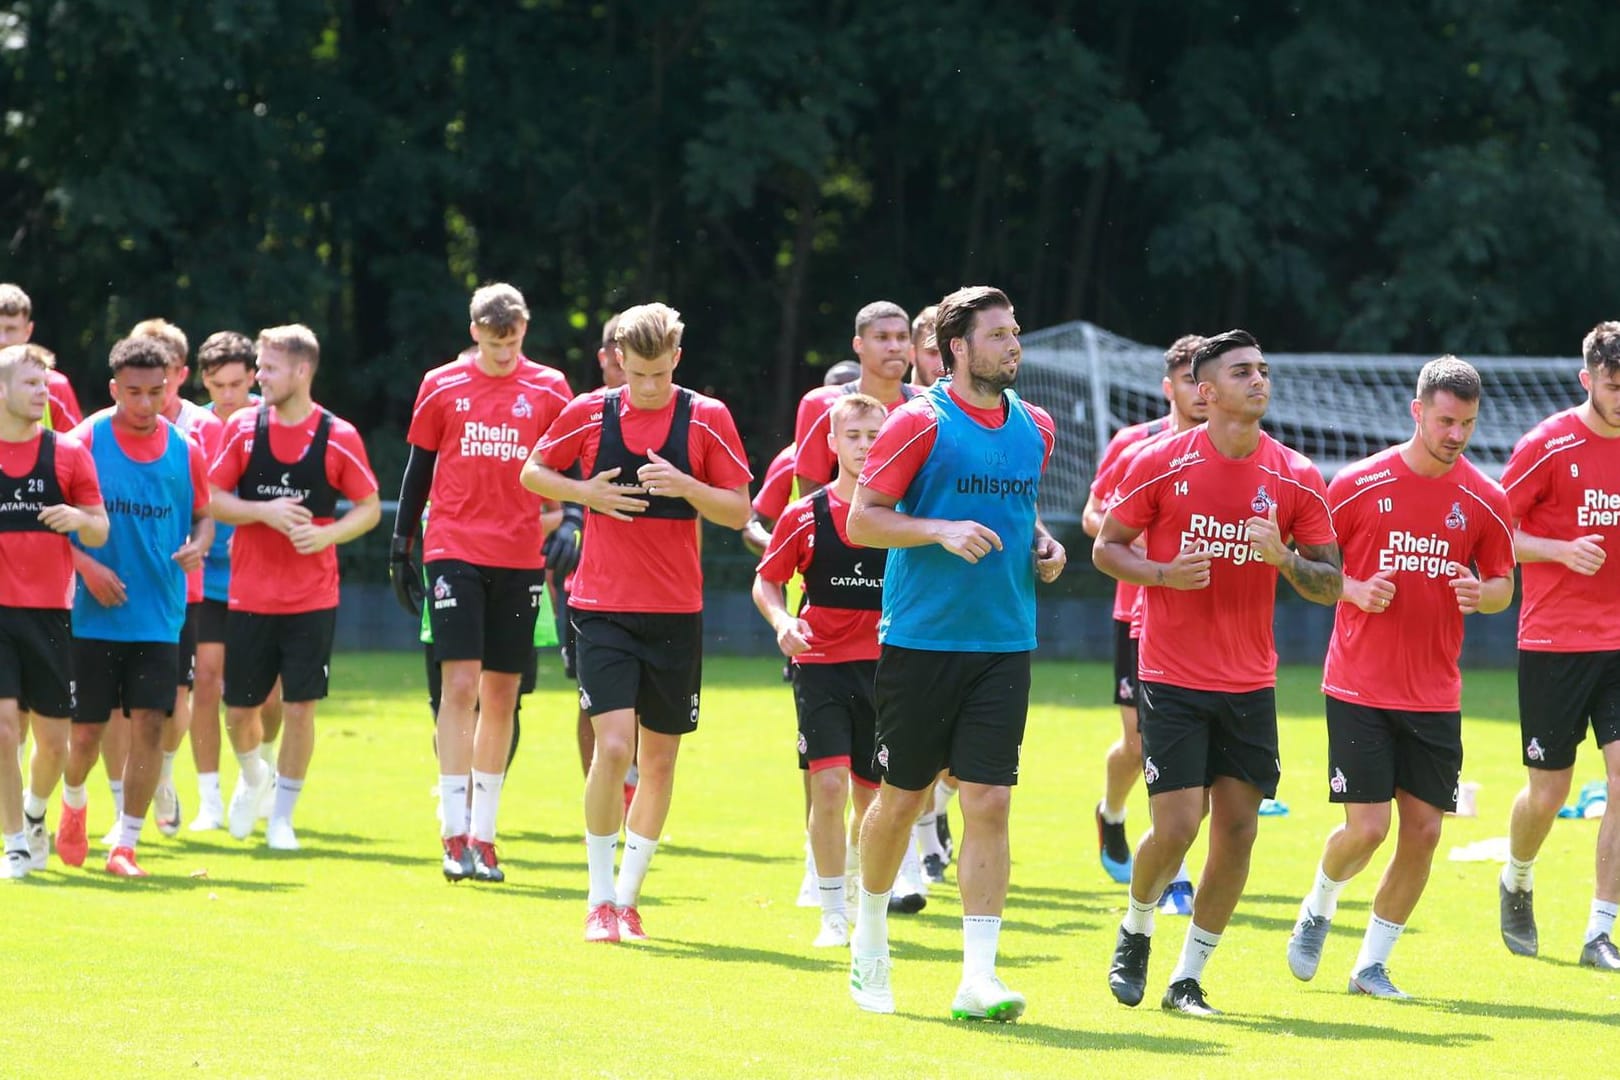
top-left (794, 661), bottom-right (878, 787)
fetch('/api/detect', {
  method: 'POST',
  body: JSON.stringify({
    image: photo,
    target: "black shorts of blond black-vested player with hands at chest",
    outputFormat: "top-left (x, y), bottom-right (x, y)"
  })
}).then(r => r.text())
top-left (569, 609), bottom-right (703, 735)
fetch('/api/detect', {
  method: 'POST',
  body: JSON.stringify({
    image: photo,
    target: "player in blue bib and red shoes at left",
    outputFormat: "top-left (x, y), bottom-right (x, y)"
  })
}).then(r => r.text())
top-left (57, 335), bottom-right (214, 878)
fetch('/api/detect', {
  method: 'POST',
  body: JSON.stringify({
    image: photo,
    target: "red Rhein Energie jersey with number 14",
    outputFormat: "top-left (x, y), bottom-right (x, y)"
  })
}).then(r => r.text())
top-left (1108, 426), bottom-right (1333, 693)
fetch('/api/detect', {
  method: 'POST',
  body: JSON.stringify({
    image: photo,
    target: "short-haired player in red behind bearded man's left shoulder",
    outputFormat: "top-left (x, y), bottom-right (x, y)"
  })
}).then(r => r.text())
top-left (794, 300), bottom-right (915, 494)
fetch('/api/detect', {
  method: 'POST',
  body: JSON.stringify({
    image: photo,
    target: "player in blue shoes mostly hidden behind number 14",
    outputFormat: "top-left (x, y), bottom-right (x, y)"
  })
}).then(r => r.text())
top-left (1081, 334), bottom-right (1209, 915)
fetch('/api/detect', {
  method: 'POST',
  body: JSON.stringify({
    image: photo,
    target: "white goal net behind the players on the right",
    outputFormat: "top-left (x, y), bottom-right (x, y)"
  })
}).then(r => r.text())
top-left (1017, 322), bottom-right (1586, 523)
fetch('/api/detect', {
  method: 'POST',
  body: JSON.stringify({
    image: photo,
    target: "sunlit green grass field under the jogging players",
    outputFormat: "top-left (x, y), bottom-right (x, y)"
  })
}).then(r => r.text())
top-left (0, 654), bottom-right (1620, 1077)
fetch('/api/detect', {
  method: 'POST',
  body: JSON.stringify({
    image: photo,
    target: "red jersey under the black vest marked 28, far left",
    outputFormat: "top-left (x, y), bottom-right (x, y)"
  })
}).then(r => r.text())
top-left (0, 431), bottom-right (102, 610)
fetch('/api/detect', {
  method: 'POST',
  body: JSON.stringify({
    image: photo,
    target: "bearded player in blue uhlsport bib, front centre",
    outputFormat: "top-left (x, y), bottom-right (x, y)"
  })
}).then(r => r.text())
top-left (849, 285), bottom-right (1066, 1022)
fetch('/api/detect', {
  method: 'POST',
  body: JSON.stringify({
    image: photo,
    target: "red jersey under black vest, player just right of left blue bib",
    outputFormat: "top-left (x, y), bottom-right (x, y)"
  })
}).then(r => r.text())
top-left (209, 406), bottom-right (377, 615)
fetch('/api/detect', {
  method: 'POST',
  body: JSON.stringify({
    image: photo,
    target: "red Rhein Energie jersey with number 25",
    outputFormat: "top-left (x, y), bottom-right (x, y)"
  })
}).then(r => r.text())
top-left (405, 353), bottom-right (573, 570)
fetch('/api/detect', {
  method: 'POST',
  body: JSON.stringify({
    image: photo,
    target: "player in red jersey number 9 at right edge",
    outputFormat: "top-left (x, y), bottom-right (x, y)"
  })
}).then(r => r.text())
top-left (1497, 322), bottom-right (1620, 972)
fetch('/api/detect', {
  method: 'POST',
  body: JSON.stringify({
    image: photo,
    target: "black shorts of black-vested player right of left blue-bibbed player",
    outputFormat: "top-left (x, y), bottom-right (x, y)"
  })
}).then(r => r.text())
top-left (224, 607), bottom-right (337, 709)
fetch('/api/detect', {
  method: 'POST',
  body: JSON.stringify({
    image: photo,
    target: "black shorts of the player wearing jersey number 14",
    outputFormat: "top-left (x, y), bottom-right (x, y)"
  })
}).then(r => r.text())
top-left (1139, 680), bottom-right (1283, 798)
